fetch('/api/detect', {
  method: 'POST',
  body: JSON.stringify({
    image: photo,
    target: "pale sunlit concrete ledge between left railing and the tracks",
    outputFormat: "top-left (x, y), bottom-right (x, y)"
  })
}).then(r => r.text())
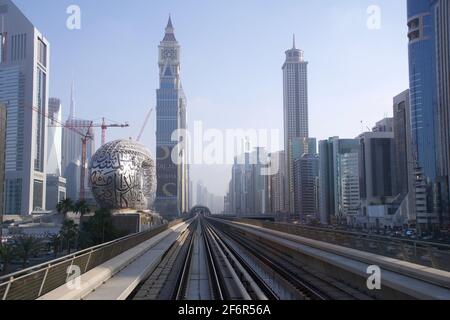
top-left (38, 220), bottom-right (193, 300)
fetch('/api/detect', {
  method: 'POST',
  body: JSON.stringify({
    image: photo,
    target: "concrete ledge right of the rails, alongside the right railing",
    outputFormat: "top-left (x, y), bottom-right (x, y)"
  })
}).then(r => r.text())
top-left (210, 218), bottom-right (450, 300)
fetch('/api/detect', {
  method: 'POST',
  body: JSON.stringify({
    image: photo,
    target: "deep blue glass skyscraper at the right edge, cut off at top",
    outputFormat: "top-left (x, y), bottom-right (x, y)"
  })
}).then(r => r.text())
top-left (408, 0), bottom-right (450, 230)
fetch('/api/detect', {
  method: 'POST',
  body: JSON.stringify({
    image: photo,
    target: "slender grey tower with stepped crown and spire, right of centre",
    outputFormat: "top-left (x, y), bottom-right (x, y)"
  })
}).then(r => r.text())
top-left (283, 36), bottom-right (309, 213)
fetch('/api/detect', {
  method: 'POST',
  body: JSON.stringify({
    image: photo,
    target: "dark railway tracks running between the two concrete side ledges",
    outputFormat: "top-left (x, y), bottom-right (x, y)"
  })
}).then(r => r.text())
top-left (130, 216), bottom-right (370, 300)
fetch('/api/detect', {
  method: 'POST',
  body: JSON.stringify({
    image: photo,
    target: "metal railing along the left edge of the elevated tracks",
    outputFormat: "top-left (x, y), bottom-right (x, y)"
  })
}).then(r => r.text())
top-left (0, 216), bottom-right (192, 300)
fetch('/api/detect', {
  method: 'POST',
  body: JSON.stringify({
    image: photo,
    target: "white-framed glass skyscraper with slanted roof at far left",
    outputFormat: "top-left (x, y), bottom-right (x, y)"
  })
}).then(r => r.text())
top-left (0, 0), bottom-right (50, 215)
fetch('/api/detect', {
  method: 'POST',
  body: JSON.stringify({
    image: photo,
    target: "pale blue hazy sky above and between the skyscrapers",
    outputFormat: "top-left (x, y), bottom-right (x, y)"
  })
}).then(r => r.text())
top-left (15, 0), bottom-right (408, 194)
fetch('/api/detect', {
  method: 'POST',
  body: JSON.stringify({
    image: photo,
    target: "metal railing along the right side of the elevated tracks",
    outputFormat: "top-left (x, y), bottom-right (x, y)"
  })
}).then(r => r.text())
top-left (227, 218), bottom-right (450, 271)
